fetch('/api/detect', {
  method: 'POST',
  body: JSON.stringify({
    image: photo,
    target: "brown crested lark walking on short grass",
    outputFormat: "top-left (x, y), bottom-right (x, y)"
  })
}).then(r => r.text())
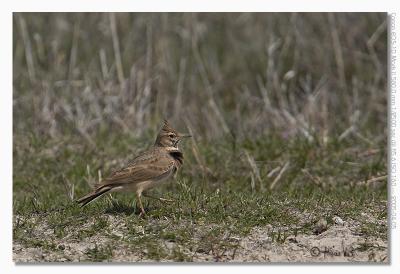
top-left (76, 120), bottom-right (191, 215)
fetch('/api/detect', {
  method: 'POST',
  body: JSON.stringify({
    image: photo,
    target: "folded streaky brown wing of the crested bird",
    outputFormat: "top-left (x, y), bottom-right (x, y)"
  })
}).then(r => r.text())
top-left (98, 155), bottom-right (175, 187)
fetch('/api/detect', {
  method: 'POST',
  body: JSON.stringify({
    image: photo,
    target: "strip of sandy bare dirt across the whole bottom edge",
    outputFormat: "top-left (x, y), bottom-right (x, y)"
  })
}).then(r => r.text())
top-left (13, 213), bottom-right (388, 263)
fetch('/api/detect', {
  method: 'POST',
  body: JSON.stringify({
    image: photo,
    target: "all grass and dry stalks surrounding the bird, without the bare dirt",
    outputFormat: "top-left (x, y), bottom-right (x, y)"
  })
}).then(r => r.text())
top-left (13, 13), bottom-right (388, 261)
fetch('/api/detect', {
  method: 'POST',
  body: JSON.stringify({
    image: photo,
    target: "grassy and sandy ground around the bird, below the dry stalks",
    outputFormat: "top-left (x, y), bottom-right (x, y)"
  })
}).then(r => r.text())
top-left (13, 134), bottom-right (388, 262)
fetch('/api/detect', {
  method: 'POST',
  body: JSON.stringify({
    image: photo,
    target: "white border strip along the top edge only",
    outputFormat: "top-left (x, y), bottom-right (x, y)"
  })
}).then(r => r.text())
top-left (2, 0), bottom-right (396, 12)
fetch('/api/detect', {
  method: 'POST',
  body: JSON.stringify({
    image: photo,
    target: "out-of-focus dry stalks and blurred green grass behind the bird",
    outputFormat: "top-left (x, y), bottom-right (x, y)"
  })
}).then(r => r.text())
top-left (13, 13), bottom-right (387, 204)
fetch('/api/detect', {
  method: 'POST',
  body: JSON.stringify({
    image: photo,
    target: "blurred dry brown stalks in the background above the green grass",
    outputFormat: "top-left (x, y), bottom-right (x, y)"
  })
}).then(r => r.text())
top-left (13, 13), bottom-right (387, 142)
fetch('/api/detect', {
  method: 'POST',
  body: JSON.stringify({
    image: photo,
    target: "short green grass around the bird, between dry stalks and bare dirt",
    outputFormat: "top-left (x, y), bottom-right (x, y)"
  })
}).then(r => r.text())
top-left (14, 132), bottom-right (387, 261)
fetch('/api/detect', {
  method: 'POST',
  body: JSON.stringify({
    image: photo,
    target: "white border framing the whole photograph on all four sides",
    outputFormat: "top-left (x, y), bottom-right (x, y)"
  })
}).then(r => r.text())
top-left (0, 0), bottom-right (400, 274)
